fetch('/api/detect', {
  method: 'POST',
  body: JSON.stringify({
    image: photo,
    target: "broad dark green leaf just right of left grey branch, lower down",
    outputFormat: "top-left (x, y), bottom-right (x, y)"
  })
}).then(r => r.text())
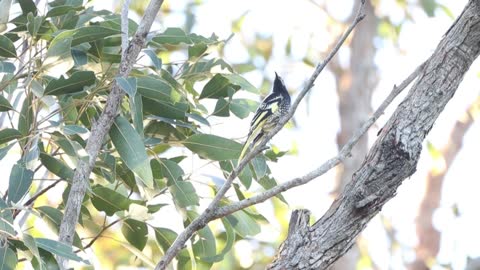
top-left (92, 186), bottom-right (132, 216)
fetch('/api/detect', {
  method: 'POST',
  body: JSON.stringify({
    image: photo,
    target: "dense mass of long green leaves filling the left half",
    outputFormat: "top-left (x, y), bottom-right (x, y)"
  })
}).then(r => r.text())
top-left (0, 0), bottom-right (284, 269)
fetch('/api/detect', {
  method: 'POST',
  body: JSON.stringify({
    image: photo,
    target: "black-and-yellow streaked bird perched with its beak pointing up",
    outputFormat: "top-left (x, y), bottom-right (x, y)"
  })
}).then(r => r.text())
top-left (238, 72), bottom-right (290, 162)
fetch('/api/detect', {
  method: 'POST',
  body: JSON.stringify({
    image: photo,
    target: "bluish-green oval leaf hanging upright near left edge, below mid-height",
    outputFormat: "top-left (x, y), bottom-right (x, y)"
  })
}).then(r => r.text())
top-left (8, 164), bottom-right (33, 203)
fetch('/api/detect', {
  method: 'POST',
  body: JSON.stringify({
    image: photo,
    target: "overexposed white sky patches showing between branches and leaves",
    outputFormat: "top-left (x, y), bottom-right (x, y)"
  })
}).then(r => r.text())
top-left (2, 0), bottom-right (480, 269)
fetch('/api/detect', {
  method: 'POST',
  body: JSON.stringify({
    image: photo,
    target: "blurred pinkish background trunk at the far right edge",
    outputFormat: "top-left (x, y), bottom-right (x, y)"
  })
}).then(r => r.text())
top-left (409, 97), bottom-right (480, 270)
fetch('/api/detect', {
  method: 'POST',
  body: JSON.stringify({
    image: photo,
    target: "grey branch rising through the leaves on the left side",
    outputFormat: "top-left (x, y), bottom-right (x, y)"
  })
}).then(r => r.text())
top-left (58, 0), bottom-right (163, 269)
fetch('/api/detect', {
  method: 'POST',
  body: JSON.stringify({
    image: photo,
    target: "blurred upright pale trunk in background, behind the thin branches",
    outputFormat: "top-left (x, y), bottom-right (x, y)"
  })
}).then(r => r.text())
top-left (330, 1), bottom-right (378, 270)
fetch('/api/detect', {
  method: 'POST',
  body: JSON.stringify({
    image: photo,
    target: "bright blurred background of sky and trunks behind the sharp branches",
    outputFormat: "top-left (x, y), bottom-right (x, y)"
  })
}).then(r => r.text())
top-left (2, 0), bottom-right (480, 270)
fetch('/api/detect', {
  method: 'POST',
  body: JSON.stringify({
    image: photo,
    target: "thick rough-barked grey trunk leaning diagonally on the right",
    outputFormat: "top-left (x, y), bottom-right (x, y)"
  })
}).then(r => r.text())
top-left (270, 0), bottom-right (480, 269)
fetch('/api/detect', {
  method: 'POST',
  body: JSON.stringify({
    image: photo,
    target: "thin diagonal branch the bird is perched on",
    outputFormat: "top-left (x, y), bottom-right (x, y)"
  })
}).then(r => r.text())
top-left (155, 0), bottom-right (365, 270)
